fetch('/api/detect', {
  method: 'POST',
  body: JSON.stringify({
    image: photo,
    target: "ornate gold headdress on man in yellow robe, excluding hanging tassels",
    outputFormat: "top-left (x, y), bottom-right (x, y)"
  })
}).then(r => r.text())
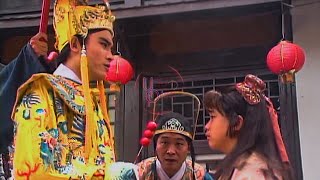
top-left (53, 0), bottom-right (115, 51)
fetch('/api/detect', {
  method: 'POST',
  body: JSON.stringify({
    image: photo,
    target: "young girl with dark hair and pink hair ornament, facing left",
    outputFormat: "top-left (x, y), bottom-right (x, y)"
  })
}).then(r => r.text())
top-left (204, 75), bottom-right (293, 180)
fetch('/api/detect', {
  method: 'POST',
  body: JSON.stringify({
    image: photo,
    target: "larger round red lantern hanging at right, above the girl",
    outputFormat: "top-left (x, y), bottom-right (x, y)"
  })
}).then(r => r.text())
top-left (267, 41), bottom-right (305, 82)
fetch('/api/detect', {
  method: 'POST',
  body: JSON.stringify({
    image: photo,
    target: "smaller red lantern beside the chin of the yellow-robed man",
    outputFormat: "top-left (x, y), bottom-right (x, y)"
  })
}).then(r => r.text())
top-left (106, 55), bottom-right (133, 90)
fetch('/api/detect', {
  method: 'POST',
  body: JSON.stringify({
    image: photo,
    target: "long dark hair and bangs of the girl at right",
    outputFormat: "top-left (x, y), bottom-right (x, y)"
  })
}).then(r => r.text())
top-left (204, 87), bottom-right (293, 180)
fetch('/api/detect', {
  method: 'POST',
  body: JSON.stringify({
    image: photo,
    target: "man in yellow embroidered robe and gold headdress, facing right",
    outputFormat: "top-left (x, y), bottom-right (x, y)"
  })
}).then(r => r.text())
top-left (12, 0), bottom-right (136, 179)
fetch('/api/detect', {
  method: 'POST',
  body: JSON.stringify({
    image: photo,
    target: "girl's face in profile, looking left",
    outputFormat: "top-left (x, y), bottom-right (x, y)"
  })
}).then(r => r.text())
top-left (205, 109), bottom-right (236, 154)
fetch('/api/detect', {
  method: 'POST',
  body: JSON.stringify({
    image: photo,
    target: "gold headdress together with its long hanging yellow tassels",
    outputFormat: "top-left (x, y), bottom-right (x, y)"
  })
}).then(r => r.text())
top-left (53, 0), bottom-right (115, 158)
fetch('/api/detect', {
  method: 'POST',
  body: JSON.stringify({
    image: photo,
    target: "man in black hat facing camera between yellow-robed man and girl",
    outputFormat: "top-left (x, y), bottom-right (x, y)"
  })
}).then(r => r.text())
top-left (138, 112), bottom-right (212, 180)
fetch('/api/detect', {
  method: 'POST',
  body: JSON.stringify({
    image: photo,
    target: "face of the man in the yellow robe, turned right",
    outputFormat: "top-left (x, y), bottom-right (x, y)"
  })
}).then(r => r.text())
top-left (86, 30), bottom-right (113, 80)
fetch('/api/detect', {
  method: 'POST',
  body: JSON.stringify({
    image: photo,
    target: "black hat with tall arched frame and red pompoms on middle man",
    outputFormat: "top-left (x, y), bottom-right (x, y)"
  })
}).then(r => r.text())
top-left (135, 91), bottom-right (200, 167)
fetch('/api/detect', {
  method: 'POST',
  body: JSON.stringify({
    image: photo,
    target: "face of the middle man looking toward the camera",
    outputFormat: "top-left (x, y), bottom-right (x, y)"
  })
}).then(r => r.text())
top-left (156, 133), bottom-right (190, 176)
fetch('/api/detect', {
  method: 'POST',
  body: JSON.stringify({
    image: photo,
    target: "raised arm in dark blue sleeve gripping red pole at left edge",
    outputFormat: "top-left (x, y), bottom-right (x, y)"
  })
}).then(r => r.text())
top-left (0, 32), bottom-right (49, 178)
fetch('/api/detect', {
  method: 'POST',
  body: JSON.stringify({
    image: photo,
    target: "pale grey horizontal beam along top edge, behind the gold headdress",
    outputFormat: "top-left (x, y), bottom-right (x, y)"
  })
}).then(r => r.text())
top-left (0, 0), bottom-right (280, 29)
